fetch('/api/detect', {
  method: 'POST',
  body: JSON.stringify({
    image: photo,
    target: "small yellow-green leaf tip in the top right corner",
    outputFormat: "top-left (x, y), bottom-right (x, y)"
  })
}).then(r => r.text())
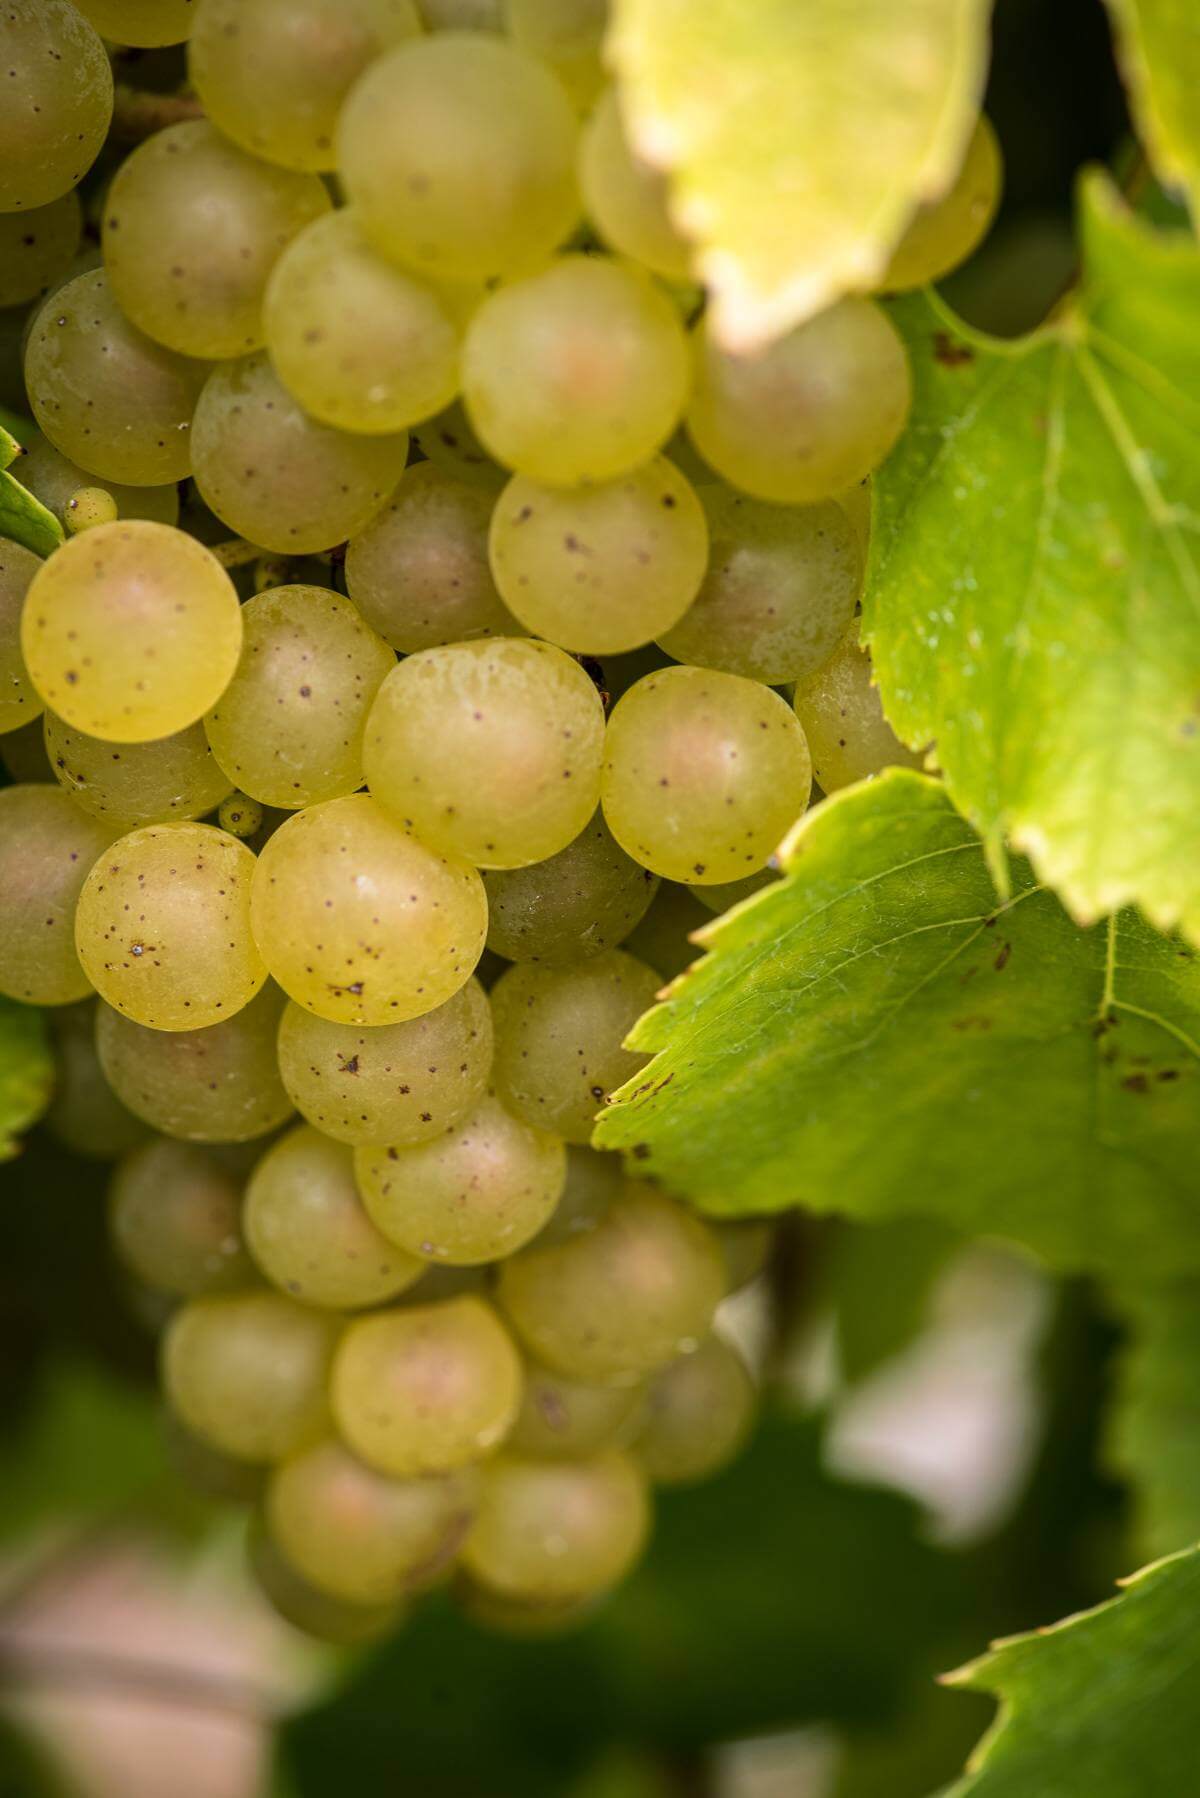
top-left (1108, 0), bottom-right (1200, 209)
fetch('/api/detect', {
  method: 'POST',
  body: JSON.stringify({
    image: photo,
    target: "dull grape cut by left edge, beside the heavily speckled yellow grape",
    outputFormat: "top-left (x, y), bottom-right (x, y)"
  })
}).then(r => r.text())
top-left (0, 786), bottom-right (113, 1005)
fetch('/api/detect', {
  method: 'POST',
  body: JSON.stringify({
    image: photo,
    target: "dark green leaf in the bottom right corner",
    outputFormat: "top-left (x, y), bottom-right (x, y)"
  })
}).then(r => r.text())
top-left (945, 1550), bottom-right (1200, 1798)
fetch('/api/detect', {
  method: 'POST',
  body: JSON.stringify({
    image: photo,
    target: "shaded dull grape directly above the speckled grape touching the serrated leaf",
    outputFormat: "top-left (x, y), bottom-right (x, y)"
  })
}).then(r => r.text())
top-left (658, 487), bottom-right (862, 687)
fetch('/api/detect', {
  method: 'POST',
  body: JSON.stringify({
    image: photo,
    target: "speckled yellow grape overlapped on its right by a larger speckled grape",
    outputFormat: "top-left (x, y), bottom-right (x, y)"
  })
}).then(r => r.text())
top-left (76, 823), bottom-right (266, 1030)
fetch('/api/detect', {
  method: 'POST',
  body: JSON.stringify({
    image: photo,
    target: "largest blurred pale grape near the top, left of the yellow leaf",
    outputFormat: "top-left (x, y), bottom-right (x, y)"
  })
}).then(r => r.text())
top-left (338, 32), bottom-right (578, 280)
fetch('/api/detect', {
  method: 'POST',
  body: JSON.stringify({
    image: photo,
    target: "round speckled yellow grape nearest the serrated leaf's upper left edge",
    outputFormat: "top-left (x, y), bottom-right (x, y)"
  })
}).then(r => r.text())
top-left (603, 667), bottom-right (811, 886)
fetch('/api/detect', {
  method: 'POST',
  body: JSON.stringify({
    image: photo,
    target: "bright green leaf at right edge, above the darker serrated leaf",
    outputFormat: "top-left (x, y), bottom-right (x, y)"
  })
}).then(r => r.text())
top-left (864, 176), bottom-right (1200, 937)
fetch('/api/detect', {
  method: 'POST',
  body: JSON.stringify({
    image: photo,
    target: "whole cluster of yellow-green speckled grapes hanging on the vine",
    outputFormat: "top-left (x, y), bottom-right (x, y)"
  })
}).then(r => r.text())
top-left (0, 0), bottom-right (999, 1640)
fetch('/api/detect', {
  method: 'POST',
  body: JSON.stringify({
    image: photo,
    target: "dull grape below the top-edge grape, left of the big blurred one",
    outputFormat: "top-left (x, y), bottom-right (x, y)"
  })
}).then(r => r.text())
top-left (103, 119), bottom-right (329, 361)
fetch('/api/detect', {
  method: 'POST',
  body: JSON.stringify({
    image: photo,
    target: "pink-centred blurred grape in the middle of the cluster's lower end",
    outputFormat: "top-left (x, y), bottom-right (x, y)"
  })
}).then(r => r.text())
top-left (331, 1296), bottom-right (522, 1480)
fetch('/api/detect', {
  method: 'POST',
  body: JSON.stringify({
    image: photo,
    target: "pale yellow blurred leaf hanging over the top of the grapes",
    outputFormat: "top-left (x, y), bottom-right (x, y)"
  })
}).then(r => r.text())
top-left (608, 0), bottom-right (990, 349)
